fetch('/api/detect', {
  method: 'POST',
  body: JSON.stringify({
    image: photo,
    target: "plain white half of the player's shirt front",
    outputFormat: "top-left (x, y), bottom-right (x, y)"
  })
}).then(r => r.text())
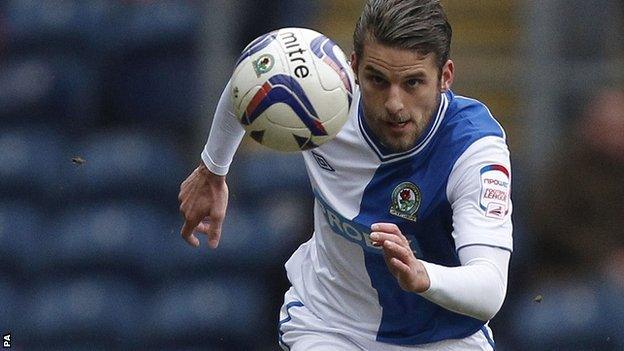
top-left (286, 89), bottom-right (381, 338)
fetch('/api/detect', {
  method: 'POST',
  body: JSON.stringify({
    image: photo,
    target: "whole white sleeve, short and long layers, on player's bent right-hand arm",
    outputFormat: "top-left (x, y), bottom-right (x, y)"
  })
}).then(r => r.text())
top-left (421, 136), bottom-right (513, 321)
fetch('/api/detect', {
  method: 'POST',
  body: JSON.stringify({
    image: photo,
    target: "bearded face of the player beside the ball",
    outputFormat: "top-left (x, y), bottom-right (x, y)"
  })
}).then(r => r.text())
top-left (351, 40), bottom-right (453, 152)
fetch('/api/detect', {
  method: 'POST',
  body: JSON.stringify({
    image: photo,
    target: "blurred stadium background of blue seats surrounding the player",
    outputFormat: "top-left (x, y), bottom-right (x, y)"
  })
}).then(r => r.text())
top-left (0, 0), bottom-right (624, 350)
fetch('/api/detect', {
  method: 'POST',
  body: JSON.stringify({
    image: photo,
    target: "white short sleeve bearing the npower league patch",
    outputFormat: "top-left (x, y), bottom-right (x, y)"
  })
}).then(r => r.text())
top-left (446, 136), bottom-right (513, 251)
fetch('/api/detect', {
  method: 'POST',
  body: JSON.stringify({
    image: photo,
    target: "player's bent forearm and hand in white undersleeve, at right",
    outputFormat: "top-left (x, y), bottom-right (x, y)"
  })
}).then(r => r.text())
top-left (371, 223), bottom-right (511, 321)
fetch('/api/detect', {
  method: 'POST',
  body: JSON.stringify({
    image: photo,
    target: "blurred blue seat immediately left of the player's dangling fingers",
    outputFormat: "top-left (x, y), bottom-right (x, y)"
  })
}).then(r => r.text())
top-left (44, 202), bottom-right (171, 280)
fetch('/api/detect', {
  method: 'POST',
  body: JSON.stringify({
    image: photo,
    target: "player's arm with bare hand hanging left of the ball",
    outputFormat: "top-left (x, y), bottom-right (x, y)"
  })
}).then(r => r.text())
top-left (178, 83), bottom-right (245, 248)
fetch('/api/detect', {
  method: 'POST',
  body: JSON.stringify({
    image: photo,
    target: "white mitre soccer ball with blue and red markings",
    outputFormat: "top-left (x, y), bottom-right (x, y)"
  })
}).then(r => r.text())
top-left (230, 28), bottom-right (355, 151)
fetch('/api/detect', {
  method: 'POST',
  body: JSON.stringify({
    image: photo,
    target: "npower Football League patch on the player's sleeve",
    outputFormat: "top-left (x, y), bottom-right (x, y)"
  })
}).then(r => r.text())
top-left (479, 164), bottom-right (511, 218)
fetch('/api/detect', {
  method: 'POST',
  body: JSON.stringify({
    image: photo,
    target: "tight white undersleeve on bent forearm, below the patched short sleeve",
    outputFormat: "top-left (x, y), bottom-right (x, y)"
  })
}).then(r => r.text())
top-left (420, 245), bottom-right (511, 321)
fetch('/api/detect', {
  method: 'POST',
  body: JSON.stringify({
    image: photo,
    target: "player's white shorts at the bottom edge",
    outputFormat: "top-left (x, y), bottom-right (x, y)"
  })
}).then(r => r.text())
top-left (278, 288), bottom-right (494, 351)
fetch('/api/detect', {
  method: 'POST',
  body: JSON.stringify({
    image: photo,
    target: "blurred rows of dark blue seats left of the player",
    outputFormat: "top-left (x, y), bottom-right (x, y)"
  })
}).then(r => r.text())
top-left (0, 0), bottom-right (312, 351)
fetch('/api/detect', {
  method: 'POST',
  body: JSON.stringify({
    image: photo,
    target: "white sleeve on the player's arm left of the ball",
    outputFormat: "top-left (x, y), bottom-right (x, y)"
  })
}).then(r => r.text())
top-left (201, 82), bottom-right (245, 175)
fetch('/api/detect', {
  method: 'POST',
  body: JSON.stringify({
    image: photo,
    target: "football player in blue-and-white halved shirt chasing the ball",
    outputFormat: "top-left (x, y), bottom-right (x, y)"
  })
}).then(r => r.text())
top-left (179, 0), bottom-right (512, 351)
